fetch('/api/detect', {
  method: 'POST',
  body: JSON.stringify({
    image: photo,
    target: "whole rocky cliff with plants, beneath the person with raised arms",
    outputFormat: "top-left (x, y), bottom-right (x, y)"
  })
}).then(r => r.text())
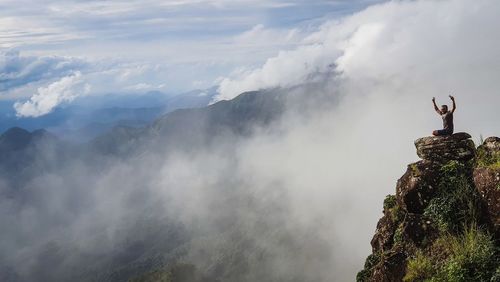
top-left (357, 133), bottom-right (500, 281)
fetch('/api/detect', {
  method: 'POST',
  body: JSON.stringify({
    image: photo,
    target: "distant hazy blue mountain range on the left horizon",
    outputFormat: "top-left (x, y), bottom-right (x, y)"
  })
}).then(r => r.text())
top-left (0, 87), bottom-right (216, 139)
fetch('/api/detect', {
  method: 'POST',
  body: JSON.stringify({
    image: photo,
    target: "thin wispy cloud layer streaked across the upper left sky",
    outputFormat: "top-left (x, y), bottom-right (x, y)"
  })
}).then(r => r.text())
top-left (0, 0), bottom-right (386, 99)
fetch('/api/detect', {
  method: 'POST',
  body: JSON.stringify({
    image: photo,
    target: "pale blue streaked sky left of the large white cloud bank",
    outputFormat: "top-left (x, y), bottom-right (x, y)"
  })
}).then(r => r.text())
top-left (0, 0), bottom-right (381, 116)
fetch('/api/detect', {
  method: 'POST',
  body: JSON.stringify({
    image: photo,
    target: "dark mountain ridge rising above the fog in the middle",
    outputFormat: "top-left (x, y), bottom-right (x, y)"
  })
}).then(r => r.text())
top-left (90, 90), bottom-right (288, 155)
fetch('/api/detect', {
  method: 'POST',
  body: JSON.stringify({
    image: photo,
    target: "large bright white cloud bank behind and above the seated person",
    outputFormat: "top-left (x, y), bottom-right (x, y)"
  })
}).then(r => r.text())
top-left (218, 0), bottom-right (499, 110)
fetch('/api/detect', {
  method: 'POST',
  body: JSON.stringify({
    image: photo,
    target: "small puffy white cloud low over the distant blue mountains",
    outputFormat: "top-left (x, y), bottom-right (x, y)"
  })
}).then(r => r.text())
top-left (14, 72), bottom-right (90, 117)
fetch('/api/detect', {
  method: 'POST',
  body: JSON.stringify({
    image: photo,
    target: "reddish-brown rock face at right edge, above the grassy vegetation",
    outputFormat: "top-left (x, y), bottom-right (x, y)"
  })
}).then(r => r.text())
top-left (474, 167), bottom-right (500, 238)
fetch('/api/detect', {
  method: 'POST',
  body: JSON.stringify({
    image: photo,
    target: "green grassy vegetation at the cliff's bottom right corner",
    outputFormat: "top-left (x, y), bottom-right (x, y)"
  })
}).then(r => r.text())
top-left (403, 225), bottom-right (500, 282)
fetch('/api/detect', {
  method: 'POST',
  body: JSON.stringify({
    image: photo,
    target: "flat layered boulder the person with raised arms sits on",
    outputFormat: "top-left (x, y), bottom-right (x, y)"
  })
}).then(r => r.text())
top-left (415, 132), bottom-right (476, 162)
